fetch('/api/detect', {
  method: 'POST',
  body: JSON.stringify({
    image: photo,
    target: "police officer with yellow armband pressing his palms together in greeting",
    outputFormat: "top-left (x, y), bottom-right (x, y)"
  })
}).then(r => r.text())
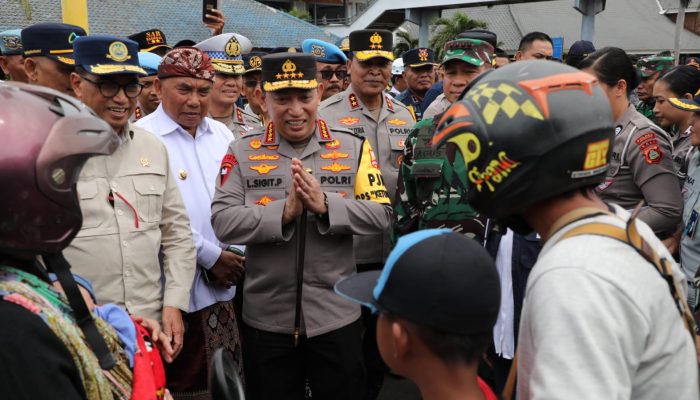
top-left (212, 53), bottom-right (391, 400)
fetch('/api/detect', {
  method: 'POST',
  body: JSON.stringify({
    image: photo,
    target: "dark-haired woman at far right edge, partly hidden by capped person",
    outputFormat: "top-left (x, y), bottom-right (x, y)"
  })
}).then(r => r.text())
top-left (654, 65), bottom-right (700, 177)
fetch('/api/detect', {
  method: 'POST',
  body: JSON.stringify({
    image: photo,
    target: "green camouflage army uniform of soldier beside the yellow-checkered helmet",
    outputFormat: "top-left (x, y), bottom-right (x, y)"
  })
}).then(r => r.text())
top-left (392, 115), bottom-right (486, 243)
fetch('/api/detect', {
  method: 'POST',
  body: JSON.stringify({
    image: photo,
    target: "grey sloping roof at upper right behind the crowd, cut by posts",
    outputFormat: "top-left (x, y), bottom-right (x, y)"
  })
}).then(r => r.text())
top-left (443, 0), bottom-right (700, 53)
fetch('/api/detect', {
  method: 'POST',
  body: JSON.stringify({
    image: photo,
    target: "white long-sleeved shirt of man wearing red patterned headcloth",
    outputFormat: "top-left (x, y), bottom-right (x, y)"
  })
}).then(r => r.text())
top-left (136, 104), bottom-right (241, 312)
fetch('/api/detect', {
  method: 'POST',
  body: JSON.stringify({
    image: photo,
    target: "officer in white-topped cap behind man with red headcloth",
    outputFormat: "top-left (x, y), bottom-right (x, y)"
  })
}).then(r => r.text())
top-left (194, 33), bottom-right (260, 137)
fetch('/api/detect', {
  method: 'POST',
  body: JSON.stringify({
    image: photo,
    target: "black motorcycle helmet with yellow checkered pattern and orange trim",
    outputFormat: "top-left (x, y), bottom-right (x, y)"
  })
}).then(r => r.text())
top-left (432, 61), bottom-right (614, 233)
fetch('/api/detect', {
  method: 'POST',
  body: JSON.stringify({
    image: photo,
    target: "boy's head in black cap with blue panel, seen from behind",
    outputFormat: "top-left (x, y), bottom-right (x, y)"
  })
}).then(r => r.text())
top-left (335, 229), bottom-right (500, 400)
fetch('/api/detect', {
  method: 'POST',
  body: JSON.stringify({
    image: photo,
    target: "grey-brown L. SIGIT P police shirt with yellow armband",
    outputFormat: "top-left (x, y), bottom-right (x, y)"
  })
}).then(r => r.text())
top-left (212, 120), bottom-right (391, 337)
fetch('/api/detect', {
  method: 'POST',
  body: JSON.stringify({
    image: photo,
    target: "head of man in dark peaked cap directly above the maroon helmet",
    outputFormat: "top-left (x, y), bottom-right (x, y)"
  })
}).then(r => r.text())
top-left (22, 23), bottom-right (86, 96)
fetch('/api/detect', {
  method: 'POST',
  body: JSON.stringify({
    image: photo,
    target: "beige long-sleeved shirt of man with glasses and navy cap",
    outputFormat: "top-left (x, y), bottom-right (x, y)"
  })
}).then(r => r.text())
top-left (63, 126), bottom-right (196, 320)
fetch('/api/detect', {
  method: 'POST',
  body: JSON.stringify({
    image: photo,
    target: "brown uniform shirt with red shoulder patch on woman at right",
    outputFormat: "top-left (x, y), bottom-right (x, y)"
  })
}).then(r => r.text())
top-left (597, 105), bottom-right (683, 235)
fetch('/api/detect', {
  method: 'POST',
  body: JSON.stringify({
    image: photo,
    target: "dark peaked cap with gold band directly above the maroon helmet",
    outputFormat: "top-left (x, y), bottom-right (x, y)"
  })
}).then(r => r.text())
top-left (21, 22), bottom-right (86, 66)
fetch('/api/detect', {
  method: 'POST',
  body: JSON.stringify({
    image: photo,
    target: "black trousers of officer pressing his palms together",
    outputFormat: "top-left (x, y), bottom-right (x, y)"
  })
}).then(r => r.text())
top-left (243, 320), bottom-right (365, 400)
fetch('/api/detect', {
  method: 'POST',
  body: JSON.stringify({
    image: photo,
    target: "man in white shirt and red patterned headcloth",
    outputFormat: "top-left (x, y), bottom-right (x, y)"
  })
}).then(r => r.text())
top-left (137, 48), bottom-right (244, 395)
